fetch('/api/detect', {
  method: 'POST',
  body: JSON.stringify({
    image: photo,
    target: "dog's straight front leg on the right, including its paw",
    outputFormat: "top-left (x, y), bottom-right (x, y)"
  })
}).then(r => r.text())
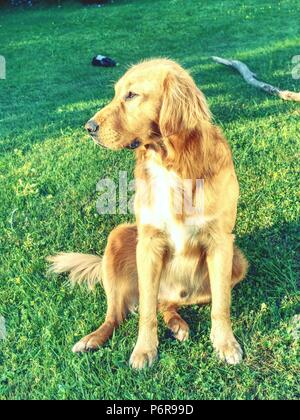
top-left (207, 234), bottom-right (243, 364)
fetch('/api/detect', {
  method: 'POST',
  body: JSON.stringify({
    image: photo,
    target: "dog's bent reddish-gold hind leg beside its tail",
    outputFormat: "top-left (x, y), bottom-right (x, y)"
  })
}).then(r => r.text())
top-left (73, 225), bottom-right (138, 353)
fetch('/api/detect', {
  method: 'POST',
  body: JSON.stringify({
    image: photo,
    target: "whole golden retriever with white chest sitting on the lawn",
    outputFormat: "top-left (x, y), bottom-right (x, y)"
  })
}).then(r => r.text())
top-left (49, 59), bottom-right (248, 369)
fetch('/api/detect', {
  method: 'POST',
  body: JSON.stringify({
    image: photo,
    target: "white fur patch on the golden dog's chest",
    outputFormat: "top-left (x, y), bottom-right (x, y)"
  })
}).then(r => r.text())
top-left (140, 161), bottom-right (200, 254)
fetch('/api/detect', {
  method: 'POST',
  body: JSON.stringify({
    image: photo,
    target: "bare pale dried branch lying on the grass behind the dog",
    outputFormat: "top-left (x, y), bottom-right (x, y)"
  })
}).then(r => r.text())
top-left (212, 57), bottom-right (300, 102)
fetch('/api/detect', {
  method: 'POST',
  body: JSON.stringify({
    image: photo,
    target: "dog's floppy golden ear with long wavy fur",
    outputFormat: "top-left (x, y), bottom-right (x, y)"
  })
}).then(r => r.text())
top-left (159, 72), bottom-right (211, 137)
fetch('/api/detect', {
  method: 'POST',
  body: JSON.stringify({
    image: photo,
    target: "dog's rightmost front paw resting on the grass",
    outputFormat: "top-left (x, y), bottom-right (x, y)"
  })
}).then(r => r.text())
top-left (211, 334), bottom-right (243, 365)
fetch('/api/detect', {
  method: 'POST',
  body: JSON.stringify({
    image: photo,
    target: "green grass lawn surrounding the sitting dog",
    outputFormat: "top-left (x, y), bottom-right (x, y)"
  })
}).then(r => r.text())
top-left (0, 0), bottom-right (300, 399)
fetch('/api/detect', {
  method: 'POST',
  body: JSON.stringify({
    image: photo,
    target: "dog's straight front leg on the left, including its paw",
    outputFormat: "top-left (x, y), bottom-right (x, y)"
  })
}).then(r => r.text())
top-left (130, 227), bottom-right (165, 369)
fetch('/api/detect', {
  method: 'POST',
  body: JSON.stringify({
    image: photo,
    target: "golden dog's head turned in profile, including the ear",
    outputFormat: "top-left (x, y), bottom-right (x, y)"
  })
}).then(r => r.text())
top-left (86, 59), bottom-right (211, 150)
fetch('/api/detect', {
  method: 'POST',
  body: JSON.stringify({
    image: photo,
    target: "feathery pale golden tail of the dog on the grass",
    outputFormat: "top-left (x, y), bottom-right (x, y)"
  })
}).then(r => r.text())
top-left (47, 252), bottom-right (102, 290)
